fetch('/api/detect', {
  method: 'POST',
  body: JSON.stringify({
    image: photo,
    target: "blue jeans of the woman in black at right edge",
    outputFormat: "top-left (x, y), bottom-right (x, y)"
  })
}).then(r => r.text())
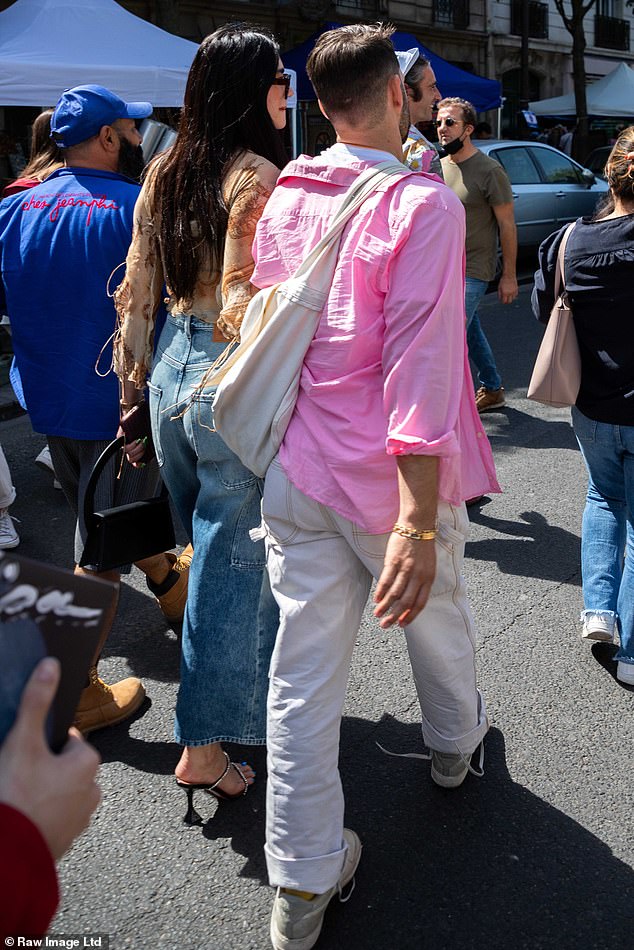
top-left (572, 406), bottom-right (634, 663)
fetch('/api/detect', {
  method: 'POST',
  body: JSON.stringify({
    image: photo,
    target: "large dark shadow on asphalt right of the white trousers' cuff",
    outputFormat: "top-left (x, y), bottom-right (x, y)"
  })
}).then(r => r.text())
top-left (328, 717), bottom-right (634, 950)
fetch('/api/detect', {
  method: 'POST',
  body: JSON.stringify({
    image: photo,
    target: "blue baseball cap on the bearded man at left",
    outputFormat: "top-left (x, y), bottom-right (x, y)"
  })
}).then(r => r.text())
top-left (51, 85), bottom-right (152, 148)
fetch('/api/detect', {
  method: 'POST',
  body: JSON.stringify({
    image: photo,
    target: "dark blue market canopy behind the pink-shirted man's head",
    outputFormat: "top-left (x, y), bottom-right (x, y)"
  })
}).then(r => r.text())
top-left (282, 23), bottom-right (502, 112)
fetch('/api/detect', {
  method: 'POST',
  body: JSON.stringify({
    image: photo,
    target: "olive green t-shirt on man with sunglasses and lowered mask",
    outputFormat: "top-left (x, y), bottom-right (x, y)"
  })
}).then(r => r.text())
top-left (441, 150), bottom-right (513, 280)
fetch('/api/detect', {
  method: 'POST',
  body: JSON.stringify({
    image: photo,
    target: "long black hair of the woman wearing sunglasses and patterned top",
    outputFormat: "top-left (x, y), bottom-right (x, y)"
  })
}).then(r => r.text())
top-left (153, 23), bottom-right (287, 301)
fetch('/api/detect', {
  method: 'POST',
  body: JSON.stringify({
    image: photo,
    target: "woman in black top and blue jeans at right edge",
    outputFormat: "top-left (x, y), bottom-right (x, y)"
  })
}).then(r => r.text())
top-left (533, 126), bottom-right (634, 685)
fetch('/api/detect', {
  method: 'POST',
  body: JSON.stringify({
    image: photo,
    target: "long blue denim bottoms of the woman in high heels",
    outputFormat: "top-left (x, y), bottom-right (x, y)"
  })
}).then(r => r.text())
top-left (149, 314), bottom-right (279, 746)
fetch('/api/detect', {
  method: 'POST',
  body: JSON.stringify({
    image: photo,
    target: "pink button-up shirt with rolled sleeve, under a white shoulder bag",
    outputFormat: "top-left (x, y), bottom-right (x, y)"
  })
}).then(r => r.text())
top-left (252, 145), bottom-right (500, 534)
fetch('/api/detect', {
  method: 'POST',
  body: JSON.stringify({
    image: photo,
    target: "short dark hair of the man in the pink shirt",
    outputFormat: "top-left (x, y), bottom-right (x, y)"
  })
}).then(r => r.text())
top-left (306, 23), bottom-right (399, 125)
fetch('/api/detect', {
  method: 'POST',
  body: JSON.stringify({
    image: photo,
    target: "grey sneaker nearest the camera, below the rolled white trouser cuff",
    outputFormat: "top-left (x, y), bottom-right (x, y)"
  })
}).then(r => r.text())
top-left (271, 828), bottom-right (361, 950)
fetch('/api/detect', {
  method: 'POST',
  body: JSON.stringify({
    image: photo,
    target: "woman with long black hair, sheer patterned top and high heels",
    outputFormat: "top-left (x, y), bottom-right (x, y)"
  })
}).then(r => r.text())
top-left (115, 24), bottom-right (288, 804)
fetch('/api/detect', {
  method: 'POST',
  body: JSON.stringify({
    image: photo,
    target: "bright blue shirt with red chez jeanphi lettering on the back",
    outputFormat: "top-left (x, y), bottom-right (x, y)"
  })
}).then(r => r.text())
top-left (0, 168), bottom-right (140, 439)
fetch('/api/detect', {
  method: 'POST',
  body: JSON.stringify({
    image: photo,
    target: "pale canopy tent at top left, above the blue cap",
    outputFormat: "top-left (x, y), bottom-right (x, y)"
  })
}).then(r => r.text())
top-left (0, 0), bottom-right (198, 107)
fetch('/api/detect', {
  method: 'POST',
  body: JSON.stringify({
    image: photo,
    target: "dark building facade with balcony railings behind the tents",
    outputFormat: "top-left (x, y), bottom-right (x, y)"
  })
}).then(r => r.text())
top-left (0, 0), bottom-right (634, 133)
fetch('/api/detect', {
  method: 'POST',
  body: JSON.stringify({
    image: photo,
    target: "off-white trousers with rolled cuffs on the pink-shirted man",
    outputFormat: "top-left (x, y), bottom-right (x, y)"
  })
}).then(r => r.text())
top-left (263, 460), bottom-right (488, 894)
